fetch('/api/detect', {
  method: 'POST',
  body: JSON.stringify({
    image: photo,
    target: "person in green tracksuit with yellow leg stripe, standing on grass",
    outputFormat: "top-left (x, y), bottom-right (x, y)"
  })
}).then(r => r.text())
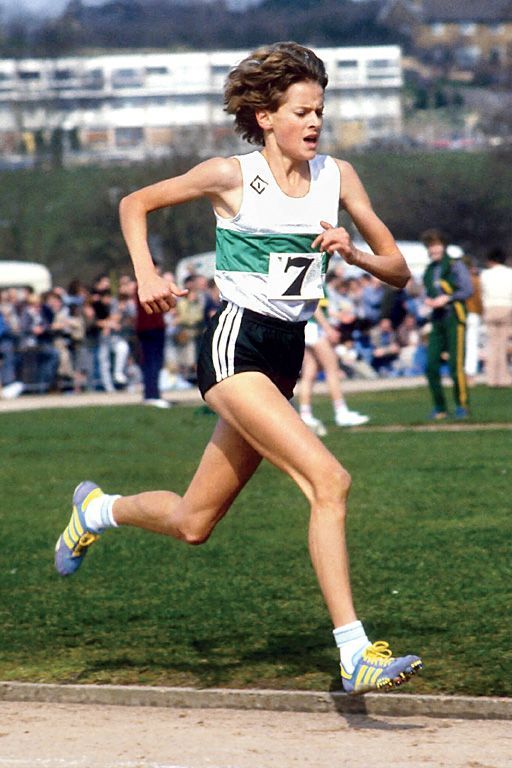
top-left (421, 229), bottom-right (473, 420)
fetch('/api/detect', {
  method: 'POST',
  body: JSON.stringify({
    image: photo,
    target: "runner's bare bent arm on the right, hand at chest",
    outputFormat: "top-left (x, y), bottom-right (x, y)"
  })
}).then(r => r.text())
top-left (313, 160), bottom-right (410, 288)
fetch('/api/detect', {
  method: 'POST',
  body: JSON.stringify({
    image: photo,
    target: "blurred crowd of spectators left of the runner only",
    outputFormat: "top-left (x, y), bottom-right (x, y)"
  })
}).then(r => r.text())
top-left (0, 274), bottom-right (218, 398)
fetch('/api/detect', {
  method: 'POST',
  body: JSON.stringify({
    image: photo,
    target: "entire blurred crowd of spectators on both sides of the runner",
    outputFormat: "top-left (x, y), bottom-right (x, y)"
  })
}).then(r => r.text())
top-left (0, 264), bottom-right (506, 398)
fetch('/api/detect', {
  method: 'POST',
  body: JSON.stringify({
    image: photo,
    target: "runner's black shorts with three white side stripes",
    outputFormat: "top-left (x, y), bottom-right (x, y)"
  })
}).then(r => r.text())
top-left (197, 302), bottom-right (306, 400)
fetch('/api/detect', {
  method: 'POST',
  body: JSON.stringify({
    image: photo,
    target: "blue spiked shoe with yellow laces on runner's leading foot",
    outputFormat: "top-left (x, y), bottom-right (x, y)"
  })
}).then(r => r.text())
top-left (340, 640), bottom-right (423, 694)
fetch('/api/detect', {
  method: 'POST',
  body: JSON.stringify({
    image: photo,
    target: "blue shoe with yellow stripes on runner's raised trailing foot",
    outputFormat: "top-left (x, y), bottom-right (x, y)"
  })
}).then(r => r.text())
top-left (55, 480), bottom-right (103, 576)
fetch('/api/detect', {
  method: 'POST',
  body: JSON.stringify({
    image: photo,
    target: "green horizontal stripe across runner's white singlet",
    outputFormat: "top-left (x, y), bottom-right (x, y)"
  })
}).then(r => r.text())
top-left (216, 228), bottom-right (327, 275)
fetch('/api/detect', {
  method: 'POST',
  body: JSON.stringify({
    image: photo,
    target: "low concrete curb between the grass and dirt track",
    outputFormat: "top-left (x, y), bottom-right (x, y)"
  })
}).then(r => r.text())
top-left (0, 682), bottom-right (512, 720)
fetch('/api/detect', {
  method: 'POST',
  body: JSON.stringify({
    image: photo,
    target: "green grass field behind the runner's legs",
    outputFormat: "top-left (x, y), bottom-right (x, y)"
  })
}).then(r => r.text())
top-left (0, 387), bottom-right (512, 696)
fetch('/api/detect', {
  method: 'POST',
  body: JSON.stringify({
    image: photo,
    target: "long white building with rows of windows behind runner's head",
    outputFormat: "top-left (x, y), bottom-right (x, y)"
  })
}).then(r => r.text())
top-left (0, 46), bottom-right (402, 157)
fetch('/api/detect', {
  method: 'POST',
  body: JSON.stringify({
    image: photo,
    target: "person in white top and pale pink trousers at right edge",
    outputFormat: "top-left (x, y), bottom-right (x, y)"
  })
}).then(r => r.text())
top-left (481, 248), bottom-right (512, 387)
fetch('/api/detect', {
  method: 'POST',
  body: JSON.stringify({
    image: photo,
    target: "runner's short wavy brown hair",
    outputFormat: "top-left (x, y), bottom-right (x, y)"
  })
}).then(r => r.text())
top-left (224, 42), bottom-right (327, 144)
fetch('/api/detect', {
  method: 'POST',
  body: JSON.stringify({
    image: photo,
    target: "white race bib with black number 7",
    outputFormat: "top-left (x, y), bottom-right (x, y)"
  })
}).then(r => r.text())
top-left (267, 253), bottom-right (324, 301)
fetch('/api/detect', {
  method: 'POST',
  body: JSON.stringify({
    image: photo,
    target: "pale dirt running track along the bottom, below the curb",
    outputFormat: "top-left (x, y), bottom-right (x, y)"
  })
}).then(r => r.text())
top-left (0, 702), bottom-right (512, 768)
